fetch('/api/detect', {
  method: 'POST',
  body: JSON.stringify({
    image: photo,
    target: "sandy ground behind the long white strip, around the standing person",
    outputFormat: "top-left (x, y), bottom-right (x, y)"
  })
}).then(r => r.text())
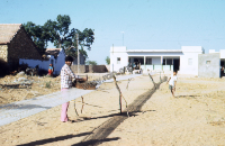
top-left (0, 73), bottom-right (110, 105)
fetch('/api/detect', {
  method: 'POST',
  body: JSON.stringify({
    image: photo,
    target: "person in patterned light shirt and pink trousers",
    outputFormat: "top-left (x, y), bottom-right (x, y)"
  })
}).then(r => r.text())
top-left (61, 56), bottom-right (76, 123)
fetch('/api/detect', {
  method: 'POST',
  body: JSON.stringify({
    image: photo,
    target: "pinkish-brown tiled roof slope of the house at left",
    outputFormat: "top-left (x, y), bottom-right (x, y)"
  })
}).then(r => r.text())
top-left (0, 24), bottom-right (22, 45)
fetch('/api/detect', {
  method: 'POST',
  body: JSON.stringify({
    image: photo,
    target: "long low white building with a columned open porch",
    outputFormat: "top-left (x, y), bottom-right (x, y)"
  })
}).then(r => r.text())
top-left (110, 46), bottom-right (204, 75)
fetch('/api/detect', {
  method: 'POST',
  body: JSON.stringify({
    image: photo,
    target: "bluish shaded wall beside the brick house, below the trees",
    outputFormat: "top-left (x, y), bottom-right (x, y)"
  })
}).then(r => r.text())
top-left (19, 51), bottom-right (65, 74)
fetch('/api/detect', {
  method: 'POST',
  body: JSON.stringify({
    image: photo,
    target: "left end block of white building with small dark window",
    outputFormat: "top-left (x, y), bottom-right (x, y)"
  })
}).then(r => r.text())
top-left (110, 47), bottom-right (128, 72)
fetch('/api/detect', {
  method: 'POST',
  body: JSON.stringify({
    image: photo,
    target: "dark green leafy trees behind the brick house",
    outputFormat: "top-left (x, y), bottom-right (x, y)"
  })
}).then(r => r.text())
top-left (23, 15), bottom-right (94, 57)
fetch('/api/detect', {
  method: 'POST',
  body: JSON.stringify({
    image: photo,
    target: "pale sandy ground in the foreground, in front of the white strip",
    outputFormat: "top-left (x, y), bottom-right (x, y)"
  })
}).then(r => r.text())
top-left (0, 75), bottom-right (225, 146)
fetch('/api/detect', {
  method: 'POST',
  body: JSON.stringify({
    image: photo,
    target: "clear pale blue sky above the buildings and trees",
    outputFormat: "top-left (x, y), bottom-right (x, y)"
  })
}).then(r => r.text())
top-left (0, 0), bottom-right (225, 64)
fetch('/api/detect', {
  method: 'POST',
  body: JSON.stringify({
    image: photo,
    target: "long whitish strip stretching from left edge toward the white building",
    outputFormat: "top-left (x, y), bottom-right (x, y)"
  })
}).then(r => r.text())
top-left (0, 74), bottom-right (140, 126)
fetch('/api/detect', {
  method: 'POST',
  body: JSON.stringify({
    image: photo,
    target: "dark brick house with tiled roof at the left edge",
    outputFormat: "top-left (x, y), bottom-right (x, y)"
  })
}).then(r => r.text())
top-left (0, 24), bottom-right (42, 70)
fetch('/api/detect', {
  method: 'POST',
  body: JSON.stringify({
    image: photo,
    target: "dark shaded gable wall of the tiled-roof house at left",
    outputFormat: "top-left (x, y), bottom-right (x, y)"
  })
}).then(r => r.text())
top-left (8, 27), bottom-right (41, 68)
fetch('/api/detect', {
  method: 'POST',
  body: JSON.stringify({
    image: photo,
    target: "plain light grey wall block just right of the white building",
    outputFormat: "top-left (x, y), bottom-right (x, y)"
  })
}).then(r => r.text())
top-left (198, 53), bottom-right (220, 78)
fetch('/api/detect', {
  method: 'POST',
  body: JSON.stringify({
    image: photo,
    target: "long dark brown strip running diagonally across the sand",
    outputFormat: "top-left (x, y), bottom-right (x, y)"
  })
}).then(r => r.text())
top-left (77, 76), bottom-right (167, 146)
